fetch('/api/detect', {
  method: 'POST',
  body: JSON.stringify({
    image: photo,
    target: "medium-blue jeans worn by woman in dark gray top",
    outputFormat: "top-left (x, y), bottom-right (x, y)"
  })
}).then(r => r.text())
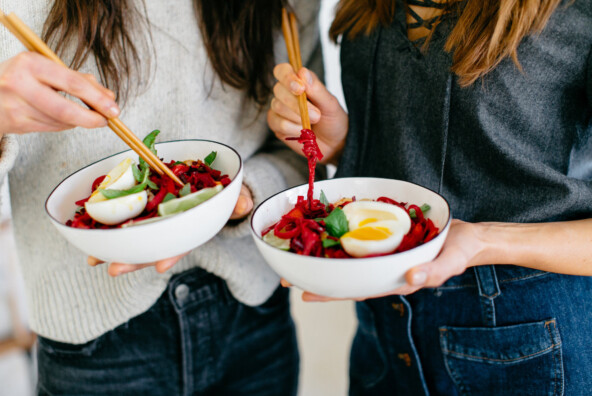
top-left (350, 266), bottom-right (592, 396)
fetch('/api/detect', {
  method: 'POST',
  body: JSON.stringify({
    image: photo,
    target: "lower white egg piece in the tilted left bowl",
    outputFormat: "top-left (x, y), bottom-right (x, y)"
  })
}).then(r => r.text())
top-left (84, 190), bottom-right (148, 225)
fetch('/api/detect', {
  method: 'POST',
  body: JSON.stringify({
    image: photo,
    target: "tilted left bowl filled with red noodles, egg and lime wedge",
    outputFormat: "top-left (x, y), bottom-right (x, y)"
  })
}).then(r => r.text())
top-left (45, 135), bottom-right (243, 264)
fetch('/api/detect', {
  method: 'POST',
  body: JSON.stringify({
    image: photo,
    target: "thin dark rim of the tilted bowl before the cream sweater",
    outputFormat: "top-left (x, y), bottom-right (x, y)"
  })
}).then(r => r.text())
top-left (44, 139), bottom-right (244, 232)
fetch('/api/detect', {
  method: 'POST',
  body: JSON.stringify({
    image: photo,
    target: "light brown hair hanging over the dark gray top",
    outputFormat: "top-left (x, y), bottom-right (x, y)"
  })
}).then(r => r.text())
top-left (329, 0), bottom-right (561, 86)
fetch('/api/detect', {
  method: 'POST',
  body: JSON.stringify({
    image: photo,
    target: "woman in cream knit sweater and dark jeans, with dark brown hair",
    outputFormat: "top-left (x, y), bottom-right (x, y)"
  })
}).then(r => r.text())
top-left (0, 0), bottom-right (319, 395)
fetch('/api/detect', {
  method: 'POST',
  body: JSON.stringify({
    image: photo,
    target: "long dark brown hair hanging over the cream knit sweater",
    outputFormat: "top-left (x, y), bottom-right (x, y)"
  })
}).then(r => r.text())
top-left (43, 0), bottom-right (287, 105)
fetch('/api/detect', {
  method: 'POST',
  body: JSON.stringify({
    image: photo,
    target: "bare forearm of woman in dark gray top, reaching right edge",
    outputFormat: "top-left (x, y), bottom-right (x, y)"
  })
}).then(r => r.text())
top-left (472, 219), bottom-right (592, 276)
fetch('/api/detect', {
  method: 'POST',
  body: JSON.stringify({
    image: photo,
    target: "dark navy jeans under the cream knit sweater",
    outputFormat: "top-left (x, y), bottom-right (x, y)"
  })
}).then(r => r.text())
top-left (38, 269), bottom-right (299, 396)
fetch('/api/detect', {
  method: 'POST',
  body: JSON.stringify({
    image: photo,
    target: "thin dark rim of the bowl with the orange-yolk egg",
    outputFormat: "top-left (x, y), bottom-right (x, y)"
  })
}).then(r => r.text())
top-left (251, 176), bottom-right (452, 263)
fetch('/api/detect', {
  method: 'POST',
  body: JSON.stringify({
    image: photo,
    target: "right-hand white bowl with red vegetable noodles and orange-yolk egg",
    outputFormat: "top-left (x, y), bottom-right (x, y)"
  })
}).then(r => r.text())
top-left (251, 178), bottom-right (452, 298)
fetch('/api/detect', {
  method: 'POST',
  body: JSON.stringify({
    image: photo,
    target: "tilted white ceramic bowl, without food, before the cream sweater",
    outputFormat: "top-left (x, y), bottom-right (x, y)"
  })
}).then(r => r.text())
top-left (45, 140), bottom-right (243, 264)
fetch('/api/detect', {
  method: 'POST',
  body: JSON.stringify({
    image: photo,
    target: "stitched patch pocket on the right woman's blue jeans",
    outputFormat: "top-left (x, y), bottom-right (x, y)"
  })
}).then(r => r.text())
top-left (440, 319), bottom-right (563, 396)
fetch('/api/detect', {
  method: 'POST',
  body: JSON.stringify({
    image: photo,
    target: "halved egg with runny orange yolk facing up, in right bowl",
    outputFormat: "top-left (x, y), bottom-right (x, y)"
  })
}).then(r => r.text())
top-left (341, 201), bottom-right (411, 257)
